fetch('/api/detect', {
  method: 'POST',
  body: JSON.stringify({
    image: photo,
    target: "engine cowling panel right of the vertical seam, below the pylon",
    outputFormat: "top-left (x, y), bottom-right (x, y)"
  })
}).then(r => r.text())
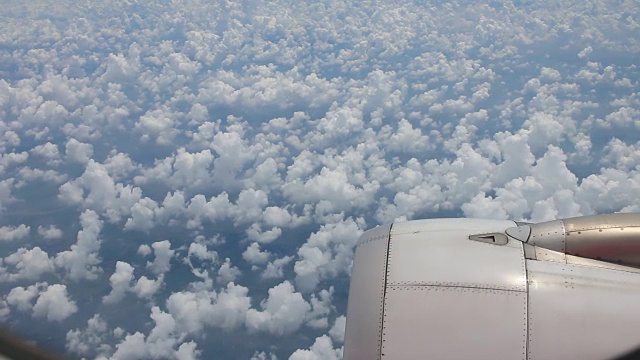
top-left (527, 260), bottom-right (640, 360)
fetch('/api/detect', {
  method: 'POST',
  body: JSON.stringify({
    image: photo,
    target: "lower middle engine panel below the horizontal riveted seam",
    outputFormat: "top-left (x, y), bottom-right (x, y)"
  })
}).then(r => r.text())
top-left (382, 286), bottom-right (527, 360)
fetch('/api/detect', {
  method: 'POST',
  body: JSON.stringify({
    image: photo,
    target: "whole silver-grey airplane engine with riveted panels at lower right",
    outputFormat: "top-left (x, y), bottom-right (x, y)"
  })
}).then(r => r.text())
top-left (344, 214), bottom-right (640, 360)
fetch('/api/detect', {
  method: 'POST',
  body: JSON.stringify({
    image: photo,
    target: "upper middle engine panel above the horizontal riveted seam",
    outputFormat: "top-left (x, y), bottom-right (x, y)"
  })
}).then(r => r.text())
top-left (387, 219), bottom-right (526, 291)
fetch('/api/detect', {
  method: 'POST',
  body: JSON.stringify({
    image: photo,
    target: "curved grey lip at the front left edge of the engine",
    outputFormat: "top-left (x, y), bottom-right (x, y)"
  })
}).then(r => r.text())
top-left (344, 225), bottom-right (391, 360)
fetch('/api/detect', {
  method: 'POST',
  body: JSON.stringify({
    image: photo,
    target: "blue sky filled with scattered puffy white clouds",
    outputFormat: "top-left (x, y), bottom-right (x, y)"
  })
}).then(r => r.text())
top-left (0, 0), bottom-right (640, 360)
